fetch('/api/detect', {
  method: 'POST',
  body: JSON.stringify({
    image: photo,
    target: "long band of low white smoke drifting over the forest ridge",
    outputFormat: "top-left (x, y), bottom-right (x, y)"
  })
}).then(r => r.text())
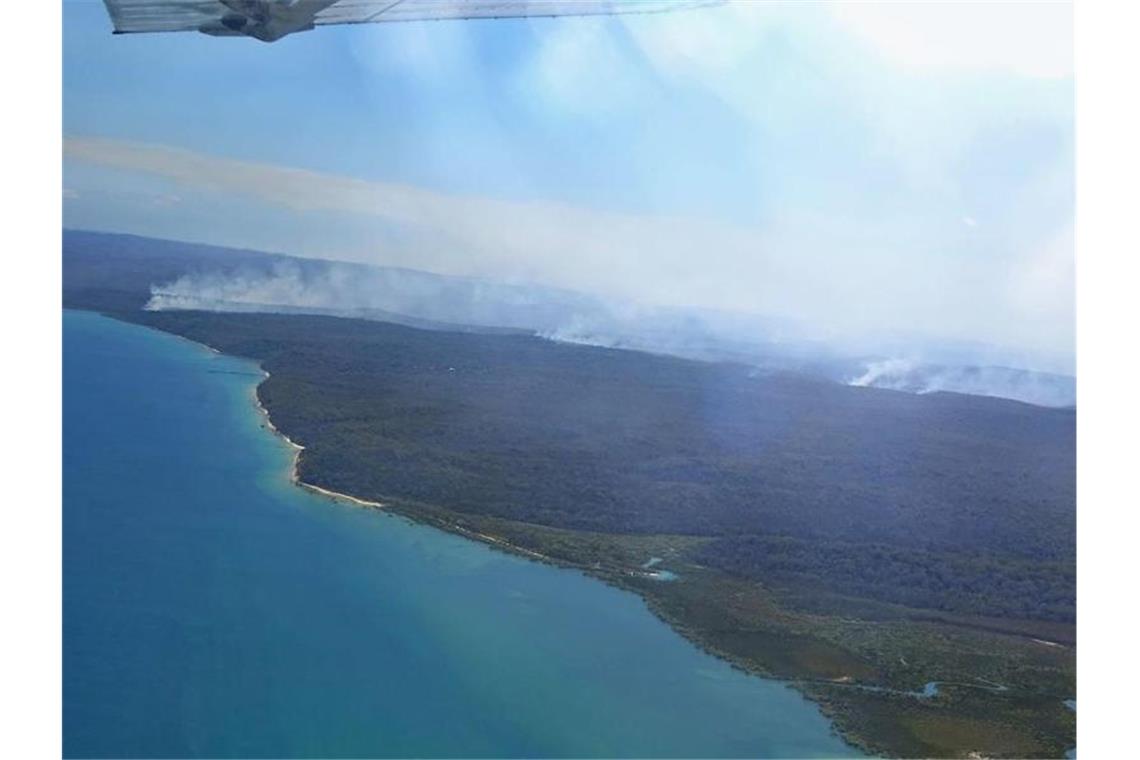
top-left (146, 259), bottom-right (1076, 407)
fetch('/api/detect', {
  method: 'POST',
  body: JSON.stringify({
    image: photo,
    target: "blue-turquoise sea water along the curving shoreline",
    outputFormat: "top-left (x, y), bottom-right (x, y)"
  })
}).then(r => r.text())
top-left (63, 312), bottom-right (852, 757)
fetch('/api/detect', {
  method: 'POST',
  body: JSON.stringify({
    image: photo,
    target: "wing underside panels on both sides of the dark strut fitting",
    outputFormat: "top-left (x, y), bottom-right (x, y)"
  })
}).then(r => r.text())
top-left (104, 0), bottom-right (719, 33)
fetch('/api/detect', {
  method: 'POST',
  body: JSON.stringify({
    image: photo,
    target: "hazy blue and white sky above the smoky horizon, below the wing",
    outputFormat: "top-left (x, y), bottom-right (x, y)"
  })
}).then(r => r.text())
top-left (63, 0), bottom-right (1075, 363)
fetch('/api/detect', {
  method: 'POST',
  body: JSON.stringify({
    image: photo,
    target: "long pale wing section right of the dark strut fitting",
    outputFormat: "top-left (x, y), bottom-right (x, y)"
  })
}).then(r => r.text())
top-left (315, 0), bottom-right (722, 26)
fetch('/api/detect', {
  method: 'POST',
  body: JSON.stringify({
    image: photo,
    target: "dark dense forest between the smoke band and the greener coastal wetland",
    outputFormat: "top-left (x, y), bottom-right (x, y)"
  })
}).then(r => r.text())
top-left (64, 232), bottom-right (1076, 621)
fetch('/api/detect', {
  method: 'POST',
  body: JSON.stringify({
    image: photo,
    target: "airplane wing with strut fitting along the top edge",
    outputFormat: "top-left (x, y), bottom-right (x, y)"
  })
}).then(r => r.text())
top-left (104, 0), bottom-right (723, 42)
